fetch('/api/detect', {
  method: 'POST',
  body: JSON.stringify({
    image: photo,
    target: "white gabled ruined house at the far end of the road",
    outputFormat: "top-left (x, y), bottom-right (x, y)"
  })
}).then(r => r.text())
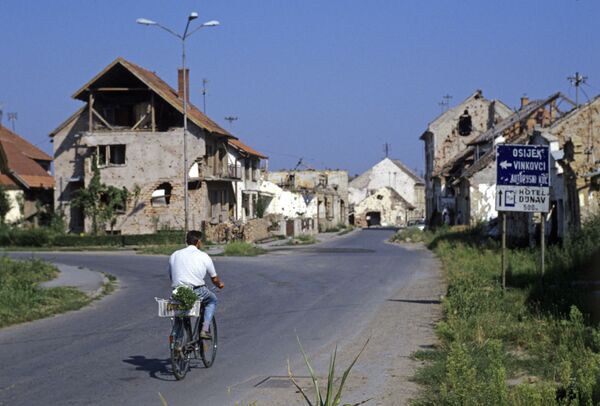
top-left (348, 158), bottom-right (425, 227)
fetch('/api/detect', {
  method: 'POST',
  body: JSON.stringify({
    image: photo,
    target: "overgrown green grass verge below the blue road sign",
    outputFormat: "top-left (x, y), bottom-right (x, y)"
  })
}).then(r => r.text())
top-left (399, 218), bottom-right (600, 405)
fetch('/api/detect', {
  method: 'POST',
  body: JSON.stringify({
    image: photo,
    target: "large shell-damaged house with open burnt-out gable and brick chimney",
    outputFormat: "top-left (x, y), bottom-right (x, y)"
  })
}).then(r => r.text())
top-left (50, 58), bottom-right (266, 234)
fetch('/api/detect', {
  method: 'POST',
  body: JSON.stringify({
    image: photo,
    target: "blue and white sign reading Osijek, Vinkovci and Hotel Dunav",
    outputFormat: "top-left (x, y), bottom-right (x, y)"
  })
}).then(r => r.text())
top-left (496, 144), bottom-right (550, 213)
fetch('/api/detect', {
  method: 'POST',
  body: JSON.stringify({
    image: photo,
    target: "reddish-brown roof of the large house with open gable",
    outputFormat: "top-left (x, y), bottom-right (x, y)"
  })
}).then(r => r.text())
top-left (73, 57), bottom-right (235, 138)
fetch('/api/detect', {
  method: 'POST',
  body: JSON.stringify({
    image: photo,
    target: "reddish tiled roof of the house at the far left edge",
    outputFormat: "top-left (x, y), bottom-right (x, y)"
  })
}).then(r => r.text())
top-left (0, 127), bottom-right (54, 188)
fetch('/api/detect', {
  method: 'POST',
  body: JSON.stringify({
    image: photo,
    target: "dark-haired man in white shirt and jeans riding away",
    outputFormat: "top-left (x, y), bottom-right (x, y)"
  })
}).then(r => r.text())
top-left (169, 230), bottom-right (225, 339)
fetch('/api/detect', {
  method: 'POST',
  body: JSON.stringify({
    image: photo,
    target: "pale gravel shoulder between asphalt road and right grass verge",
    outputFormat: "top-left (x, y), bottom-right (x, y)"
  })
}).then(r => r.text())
top-left (240, 244), bottom-right (445, 406)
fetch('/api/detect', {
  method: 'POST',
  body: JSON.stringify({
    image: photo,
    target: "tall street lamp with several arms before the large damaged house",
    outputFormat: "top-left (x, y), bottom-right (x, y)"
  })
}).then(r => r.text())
top-left (135, 11), bottom-right (220, 233)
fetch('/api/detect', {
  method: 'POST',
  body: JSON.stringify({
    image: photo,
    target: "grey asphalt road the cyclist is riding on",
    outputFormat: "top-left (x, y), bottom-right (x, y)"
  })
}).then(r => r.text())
top-left (0, 230), bottom-right (429, 406)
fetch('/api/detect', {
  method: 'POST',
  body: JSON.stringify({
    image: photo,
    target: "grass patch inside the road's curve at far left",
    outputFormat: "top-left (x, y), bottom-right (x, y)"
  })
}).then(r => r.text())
top-left (0, 257), bottom-right (91, 327)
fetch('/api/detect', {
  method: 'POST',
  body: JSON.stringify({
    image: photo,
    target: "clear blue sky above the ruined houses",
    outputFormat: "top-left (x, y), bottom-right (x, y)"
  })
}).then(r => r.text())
top-left (0, 0), bottom-right (600, 175)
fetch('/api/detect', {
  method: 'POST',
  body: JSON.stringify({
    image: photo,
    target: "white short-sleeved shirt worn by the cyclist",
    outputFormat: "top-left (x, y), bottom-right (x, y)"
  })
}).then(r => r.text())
top-left (169, 245), bottom-right (217, 288)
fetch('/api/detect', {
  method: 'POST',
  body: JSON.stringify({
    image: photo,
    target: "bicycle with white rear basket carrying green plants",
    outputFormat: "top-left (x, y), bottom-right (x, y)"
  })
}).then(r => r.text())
top-left (155, 290), bottom-right (217, 381)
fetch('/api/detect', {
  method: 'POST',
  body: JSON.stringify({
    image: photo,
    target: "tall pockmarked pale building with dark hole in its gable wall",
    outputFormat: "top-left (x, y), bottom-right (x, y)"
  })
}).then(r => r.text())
top-left (420, 90), bottom-right (513, 226)
